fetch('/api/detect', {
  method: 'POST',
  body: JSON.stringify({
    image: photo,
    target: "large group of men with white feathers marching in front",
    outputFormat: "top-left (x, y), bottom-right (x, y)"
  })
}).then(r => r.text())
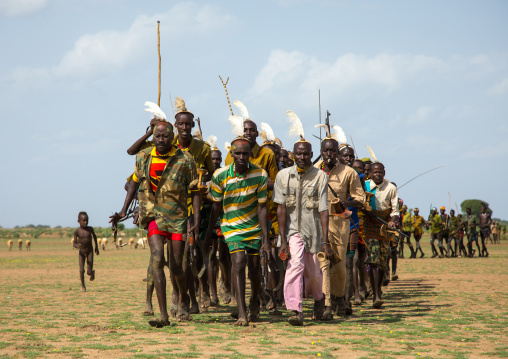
top-left (111, 97), bottom-right (496, 327)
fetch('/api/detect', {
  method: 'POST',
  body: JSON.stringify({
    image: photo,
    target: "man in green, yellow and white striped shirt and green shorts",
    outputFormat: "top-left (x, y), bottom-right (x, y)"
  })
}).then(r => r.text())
top-left (206, 136), bottom-right (270, 326)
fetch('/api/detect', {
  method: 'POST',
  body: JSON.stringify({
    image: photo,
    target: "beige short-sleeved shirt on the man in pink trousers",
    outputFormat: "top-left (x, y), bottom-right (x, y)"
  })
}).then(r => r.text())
top-left (273, 165), bottom-right (328, 253)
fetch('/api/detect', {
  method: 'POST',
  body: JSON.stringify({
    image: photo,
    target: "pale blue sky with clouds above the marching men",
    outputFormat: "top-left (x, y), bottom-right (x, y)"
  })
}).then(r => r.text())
top-left (0, 0), bottom-right (508, 227)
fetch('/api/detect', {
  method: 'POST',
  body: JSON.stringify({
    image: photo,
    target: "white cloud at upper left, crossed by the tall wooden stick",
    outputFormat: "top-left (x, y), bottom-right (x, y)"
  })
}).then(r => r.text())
top-left (12, 2), bottom-right (237, 82)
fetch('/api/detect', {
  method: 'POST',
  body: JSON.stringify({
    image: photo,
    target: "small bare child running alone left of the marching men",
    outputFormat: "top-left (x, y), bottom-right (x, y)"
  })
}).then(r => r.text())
top-left (74, 214), bottom-right (99, 292)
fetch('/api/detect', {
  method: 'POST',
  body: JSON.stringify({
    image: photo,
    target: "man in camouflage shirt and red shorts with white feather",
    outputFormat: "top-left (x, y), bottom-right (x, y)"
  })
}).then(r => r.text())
top-left (110, 103), bottom-right (200, 327)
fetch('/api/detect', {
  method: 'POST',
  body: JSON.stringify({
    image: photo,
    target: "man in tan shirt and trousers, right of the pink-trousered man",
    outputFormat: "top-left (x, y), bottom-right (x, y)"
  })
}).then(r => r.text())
top-left (315, 125), bottom-right (365, 319)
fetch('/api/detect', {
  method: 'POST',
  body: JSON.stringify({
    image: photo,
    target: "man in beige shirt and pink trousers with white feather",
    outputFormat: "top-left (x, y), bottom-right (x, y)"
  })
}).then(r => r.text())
top-left (274, 111), bottom-right (333, 326)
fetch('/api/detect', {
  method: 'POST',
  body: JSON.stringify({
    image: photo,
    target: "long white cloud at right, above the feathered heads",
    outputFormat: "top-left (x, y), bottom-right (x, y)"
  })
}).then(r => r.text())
top-left (250, 50), bottom-right (448, 104)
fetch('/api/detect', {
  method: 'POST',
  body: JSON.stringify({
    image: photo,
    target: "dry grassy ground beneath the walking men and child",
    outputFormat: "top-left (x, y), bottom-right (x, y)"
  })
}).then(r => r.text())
top-left (0, 238), bottom-right (508, 359)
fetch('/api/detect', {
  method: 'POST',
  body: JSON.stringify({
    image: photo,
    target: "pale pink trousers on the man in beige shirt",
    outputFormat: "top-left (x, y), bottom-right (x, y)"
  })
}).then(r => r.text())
top-left (284, 233), bottom-right (323, 312)
